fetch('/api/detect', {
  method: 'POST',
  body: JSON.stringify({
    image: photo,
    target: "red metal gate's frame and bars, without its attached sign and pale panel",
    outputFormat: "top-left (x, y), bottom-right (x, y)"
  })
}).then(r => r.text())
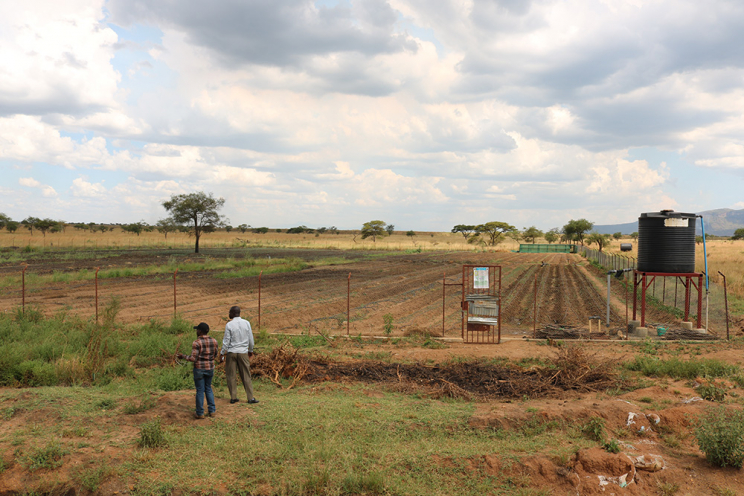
top-left (460, 265), bottom-right (501, 344)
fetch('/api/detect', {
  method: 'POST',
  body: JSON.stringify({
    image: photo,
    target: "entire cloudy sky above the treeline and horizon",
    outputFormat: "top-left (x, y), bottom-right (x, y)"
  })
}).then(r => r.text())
top-left (0, 0), bottom-right (744, 231)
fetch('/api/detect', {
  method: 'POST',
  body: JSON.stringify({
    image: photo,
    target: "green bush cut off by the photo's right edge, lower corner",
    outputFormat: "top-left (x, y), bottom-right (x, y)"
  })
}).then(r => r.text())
top-left (695, 406), bottom-right (744, 468)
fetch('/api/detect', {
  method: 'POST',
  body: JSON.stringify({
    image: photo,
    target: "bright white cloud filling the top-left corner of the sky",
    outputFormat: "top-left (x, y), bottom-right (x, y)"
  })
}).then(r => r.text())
top-left (0, 0), bottom-right (119, 116)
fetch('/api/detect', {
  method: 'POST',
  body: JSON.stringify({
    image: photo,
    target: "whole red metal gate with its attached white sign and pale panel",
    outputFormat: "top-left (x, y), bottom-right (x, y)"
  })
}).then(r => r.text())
top-left (461, 265), bottom-right (501, 343)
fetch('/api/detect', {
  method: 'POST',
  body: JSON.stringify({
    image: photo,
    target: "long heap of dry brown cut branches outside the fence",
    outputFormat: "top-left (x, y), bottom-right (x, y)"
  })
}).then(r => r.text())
top-left (251, 343), bottom-right (623, 399)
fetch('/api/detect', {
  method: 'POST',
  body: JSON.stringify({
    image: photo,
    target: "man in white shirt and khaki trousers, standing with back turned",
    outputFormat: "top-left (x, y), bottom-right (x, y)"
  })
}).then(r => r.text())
top-left (220, 306), bottom-right (258, 404)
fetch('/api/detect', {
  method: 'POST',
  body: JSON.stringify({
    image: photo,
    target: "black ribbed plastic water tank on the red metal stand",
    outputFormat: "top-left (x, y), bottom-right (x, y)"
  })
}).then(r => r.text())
top-left (637, 210), bottom-right (696, 273)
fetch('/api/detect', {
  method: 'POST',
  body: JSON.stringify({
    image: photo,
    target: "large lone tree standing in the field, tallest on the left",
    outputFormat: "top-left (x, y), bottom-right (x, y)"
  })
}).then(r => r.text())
top-left (163, 191), bottom-right (225, 253)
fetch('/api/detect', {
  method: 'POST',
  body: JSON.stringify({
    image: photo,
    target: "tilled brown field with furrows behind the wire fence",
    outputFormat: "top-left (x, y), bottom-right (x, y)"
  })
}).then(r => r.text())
top-left (0, 249), bottom-right (676, 336)
